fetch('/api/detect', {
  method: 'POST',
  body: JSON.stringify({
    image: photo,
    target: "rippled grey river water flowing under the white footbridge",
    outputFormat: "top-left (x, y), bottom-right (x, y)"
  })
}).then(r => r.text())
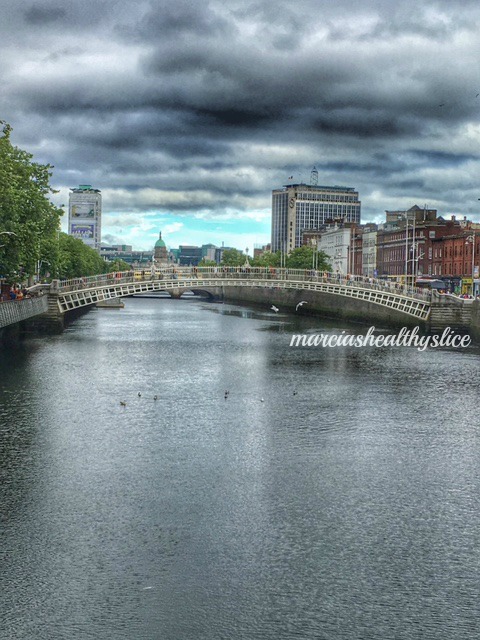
top-left (0, 298), bottom-right (480, 640)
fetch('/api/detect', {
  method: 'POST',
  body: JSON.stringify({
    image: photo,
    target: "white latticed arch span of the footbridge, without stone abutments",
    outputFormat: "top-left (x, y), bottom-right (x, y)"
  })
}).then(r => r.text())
top-left (56, 267), bottom-right (431, 323)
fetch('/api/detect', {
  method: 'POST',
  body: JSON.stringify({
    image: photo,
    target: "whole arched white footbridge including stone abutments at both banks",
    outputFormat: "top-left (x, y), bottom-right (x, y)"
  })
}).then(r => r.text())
top-left (0, 267), bottom-right (480, 337)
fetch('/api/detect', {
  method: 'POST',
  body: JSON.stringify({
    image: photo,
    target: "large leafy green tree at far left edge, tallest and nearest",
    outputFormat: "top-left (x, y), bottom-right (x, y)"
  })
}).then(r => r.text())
top-left (0, 120), bottom-right (63, 278)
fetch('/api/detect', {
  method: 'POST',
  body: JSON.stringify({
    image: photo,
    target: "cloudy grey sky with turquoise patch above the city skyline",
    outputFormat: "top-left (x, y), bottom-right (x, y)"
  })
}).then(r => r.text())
top-left (0, 0), bottom-right (480, 253)
